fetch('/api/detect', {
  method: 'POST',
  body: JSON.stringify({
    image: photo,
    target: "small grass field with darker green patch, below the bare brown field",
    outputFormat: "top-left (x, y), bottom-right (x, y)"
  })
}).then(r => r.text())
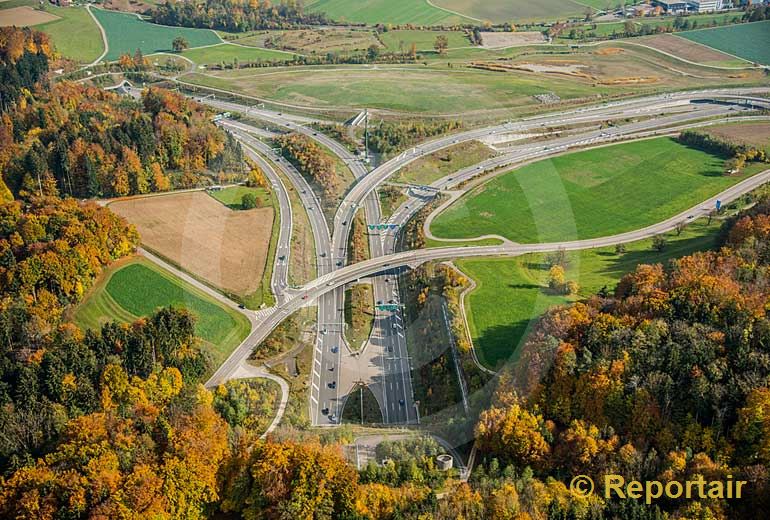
top-left (73, 258), bottom-right (249, 364)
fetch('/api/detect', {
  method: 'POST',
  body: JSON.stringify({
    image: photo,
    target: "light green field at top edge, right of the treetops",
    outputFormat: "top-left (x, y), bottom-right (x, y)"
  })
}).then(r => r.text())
top-left (307, 0), bottom-right (472, 25)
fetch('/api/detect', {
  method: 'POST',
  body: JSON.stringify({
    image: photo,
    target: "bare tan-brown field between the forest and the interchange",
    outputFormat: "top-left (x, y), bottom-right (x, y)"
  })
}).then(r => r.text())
top-left (110, 191), bottom-right (274, 296)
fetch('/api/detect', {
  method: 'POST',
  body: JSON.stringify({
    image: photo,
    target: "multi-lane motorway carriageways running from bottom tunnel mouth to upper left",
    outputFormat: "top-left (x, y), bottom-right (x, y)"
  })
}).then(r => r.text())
top-left (222, 117), bottom-right (417, 424)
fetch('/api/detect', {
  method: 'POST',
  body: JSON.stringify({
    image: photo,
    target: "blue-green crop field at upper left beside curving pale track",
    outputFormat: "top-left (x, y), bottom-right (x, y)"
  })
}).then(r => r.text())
top-left (93, 9), bottom-right (222, 60)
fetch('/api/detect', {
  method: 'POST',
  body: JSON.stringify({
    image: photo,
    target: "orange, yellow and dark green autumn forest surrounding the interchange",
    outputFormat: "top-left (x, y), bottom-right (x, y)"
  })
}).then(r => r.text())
top-left (0, 20), bottom-right (770, 520)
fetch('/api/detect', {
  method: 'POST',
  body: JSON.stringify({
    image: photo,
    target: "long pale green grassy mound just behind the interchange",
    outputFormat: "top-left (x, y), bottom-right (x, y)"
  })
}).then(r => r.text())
top-left (184, 65), bottom-right (623, 114)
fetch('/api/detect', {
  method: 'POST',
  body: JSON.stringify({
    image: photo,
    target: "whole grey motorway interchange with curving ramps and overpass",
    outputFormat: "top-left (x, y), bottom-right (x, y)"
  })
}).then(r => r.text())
top-left (194, 89), bottom-right (770, 425)
